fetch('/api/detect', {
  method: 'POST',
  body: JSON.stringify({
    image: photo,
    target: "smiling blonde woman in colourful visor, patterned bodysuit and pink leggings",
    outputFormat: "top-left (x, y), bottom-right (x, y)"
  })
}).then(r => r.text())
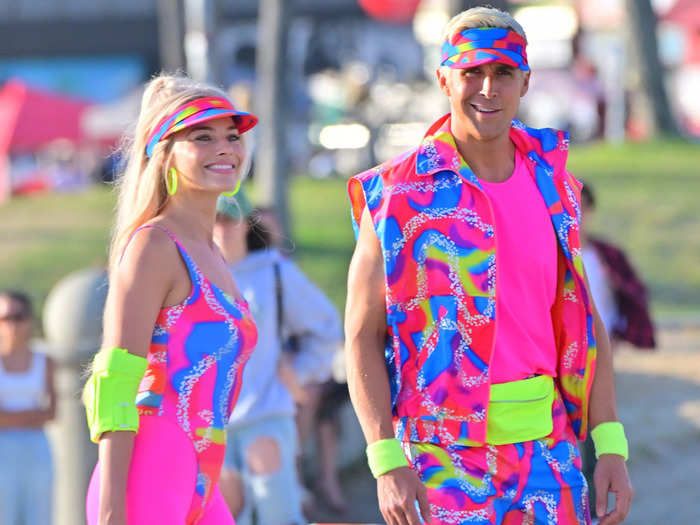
top-left (84, 75), bottom-right (257, 525)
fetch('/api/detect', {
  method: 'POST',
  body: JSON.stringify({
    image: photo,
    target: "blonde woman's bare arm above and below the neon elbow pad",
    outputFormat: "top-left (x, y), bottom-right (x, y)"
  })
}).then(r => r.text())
top-left (99, 228), bottom-right (182, 525)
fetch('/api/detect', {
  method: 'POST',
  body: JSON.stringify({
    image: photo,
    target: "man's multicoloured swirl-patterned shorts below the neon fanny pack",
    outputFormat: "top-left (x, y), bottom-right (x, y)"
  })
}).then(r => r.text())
top-left (404, 399), bottom-right (591, 525)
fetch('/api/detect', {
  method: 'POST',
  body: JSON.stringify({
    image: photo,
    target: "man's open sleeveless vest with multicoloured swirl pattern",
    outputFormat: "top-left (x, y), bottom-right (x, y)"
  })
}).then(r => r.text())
top-left (348, 114), bottom-right (596, 445)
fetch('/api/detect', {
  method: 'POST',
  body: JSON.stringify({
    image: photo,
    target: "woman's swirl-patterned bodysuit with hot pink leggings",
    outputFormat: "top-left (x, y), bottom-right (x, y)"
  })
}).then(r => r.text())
top-left (87, 224), bottom-right (257, 525)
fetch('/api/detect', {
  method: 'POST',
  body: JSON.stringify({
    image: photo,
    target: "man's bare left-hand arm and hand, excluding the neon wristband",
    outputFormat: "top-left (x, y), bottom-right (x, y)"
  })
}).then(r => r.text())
top-left (345, 208), bottom-right (430, 525)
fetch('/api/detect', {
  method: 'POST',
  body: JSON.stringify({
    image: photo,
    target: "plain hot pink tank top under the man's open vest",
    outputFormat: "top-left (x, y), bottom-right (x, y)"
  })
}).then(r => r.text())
top-left (479, 150), bottom-right (557, 383)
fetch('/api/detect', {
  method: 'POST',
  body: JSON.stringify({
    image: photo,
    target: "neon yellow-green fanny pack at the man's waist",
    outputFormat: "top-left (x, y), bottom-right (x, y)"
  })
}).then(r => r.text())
top-left (486, 375), bottom-right (554, 445)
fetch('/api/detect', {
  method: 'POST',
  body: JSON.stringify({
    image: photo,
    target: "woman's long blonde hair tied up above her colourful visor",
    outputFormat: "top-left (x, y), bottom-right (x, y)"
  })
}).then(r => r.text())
top-left (109, 74), bottom-right (250, 273)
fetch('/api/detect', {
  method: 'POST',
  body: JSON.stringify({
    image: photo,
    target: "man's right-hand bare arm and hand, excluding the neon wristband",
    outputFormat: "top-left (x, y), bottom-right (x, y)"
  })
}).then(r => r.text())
top-left (584, 272), bottom-right (634, 525)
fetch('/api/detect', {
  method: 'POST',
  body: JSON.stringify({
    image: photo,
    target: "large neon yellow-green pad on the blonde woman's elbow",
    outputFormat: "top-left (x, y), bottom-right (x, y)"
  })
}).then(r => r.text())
top-left (83, 348), bottom-right (148, 443)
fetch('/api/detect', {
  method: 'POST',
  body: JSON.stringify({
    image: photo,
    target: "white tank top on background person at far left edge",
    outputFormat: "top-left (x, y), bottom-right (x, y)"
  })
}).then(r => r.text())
top-left (0, 353), bottom-right (47, 412)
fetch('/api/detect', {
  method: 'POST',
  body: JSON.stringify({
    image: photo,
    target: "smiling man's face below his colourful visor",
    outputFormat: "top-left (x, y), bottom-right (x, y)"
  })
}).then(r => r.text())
top-left (437, 62), bottom-right (530, 142)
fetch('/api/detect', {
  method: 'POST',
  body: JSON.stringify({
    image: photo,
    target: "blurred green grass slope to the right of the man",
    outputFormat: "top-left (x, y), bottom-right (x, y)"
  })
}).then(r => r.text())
top-left (569, 142), bottom-right (700, 311)
